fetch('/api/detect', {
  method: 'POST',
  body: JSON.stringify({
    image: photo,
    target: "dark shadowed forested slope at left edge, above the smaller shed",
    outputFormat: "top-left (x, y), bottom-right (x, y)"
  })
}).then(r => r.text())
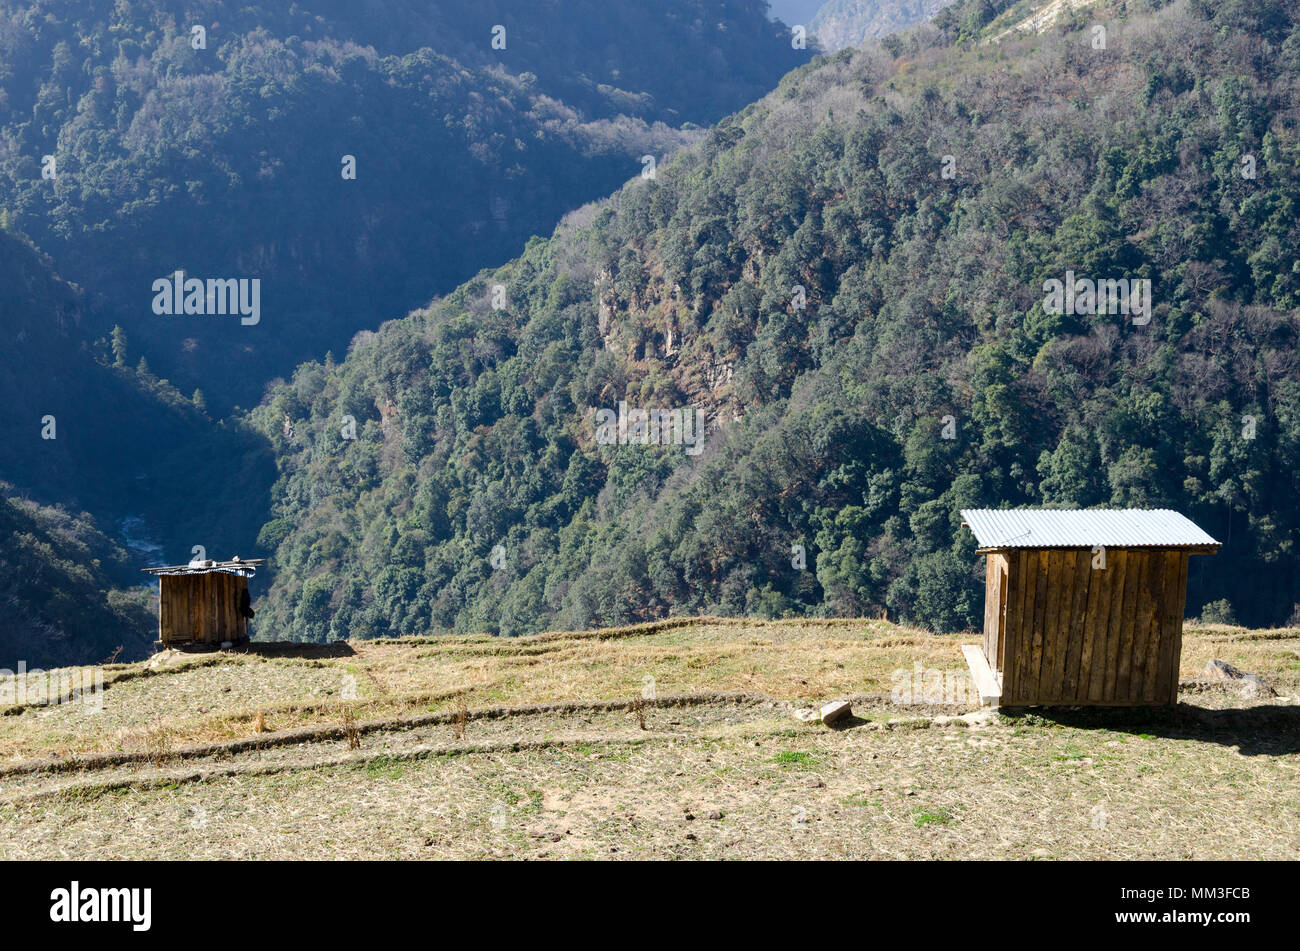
top-left (0, 231), bottom-right (274, 543)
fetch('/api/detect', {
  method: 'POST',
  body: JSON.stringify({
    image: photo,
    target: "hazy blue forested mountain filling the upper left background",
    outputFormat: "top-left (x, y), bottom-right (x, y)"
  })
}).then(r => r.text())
top-left (0, 0), bottom-right (809, 413)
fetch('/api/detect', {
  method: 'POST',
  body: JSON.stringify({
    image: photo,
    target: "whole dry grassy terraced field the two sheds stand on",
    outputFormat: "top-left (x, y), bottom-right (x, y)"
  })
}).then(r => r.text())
top-left (0, 618), bottom-right (1300, 859)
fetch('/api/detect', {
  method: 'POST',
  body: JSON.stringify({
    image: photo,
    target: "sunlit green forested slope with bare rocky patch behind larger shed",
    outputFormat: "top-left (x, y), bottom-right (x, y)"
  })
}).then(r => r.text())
top-left (255, 0), bottom-right (1300, 638)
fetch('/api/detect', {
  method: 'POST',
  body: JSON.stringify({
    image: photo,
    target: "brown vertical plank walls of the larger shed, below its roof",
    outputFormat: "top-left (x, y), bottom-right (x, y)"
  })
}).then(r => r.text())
top-left (984, 548), bottom-right (1188, 705)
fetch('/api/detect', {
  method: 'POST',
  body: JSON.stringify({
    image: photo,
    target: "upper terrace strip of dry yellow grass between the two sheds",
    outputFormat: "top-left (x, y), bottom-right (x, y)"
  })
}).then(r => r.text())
top-left (0, 621), bottom-right (946, 763)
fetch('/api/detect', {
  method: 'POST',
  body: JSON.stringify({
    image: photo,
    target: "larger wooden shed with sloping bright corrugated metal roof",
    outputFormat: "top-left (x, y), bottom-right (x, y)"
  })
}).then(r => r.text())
top-left (962, 509), bottom-right (1219, 707)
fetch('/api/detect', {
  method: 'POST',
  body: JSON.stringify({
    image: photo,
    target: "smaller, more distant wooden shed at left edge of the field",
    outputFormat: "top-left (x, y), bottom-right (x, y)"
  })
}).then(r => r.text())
top-left (144, 556), bottom-right (265, 650)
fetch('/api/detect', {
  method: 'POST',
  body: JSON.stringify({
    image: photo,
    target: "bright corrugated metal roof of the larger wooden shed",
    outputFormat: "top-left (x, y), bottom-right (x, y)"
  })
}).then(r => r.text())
top-left (962, 508), bottom-right (1218, 548)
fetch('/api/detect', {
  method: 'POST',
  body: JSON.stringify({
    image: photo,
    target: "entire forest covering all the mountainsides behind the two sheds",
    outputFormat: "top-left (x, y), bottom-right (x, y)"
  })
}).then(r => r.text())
top-left (0, 0), bottom-right (1300, 663)
